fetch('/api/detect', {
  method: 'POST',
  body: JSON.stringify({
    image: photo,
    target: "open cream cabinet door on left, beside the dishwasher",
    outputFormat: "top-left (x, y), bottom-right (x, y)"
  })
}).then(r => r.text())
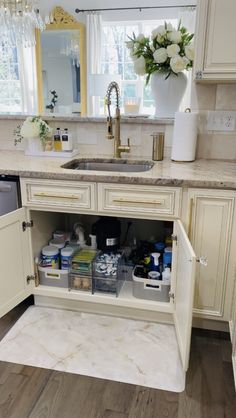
top-left (0, 208), bottom-right (33, 317)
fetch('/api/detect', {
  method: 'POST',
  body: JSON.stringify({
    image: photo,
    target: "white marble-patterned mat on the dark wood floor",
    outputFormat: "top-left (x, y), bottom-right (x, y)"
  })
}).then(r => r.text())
top-left (0, 306), bottom-right (185, 392)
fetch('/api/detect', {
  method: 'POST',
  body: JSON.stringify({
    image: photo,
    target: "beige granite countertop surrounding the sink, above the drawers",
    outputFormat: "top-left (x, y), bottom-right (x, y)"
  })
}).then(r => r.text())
top-left (0, 151), bottom-right (236, 190)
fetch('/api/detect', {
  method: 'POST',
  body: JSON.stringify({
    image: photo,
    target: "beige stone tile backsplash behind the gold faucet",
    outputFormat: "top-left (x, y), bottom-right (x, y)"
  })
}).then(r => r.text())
top-left (0, 83), bottom-right (236, 160)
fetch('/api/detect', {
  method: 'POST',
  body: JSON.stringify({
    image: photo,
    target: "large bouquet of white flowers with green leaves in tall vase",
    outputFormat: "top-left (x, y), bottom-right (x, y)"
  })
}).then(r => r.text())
top-left (126, 21), bottom-right (194, 84)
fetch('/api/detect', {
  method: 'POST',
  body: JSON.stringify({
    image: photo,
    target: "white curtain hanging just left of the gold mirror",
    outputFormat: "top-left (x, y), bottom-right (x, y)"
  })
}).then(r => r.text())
top-left (17, 45), bottom-right (38, 115)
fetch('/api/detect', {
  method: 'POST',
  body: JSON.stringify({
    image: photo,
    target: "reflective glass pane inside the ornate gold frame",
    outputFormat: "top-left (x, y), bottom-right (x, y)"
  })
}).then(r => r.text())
top-left (40, 30), bottom-right (81, 114)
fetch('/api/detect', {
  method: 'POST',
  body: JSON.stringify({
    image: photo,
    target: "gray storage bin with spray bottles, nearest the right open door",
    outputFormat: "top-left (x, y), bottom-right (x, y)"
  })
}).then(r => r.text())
top-left (133, 270), bottom-right (170, 302)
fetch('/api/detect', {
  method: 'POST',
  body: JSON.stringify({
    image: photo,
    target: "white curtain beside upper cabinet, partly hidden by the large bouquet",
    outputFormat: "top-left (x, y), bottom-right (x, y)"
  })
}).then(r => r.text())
top-left (178, 7), bottom-right (196, 111)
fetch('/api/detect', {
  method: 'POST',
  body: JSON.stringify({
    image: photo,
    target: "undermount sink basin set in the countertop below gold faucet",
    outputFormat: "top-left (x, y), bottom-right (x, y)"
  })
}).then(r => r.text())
top-left (62, 158), bottom-right (154, 173)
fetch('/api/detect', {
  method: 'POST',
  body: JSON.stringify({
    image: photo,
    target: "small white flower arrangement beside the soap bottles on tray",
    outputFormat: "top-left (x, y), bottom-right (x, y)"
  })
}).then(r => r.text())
top-left (14, 116), bottom-right (52, 144)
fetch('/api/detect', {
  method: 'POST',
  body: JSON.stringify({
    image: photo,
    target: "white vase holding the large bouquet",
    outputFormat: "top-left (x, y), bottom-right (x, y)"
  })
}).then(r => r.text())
top-left (151, 73), bottom-right (188, 118)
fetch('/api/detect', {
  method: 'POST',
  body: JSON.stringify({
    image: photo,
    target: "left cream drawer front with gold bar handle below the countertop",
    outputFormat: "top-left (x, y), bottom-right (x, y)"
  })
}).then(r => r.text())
top-left (21, 179), bottom-right (96, 211)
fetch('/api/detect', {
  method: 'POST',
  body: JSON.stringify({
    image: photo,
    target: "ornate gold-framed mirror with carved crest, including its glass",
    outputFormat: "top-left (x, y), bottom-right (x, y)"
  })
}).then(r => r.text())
top-left (36, 6), bottom-right (87, 115)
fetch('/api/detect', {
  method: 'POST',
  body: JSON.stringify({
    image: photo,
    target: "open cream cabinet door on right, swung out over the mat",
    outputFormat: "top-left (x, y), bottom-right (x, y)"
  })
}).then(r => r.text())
top-left (173, 221), bottom-right (196, 371)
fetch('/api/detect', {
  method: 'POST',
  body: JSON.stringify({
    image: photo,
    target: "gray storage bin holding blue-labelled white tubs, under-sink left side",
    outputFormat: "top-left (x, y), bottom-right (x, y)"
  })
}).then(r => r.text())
top-left (38, 266), bottom-right (68, 288)
